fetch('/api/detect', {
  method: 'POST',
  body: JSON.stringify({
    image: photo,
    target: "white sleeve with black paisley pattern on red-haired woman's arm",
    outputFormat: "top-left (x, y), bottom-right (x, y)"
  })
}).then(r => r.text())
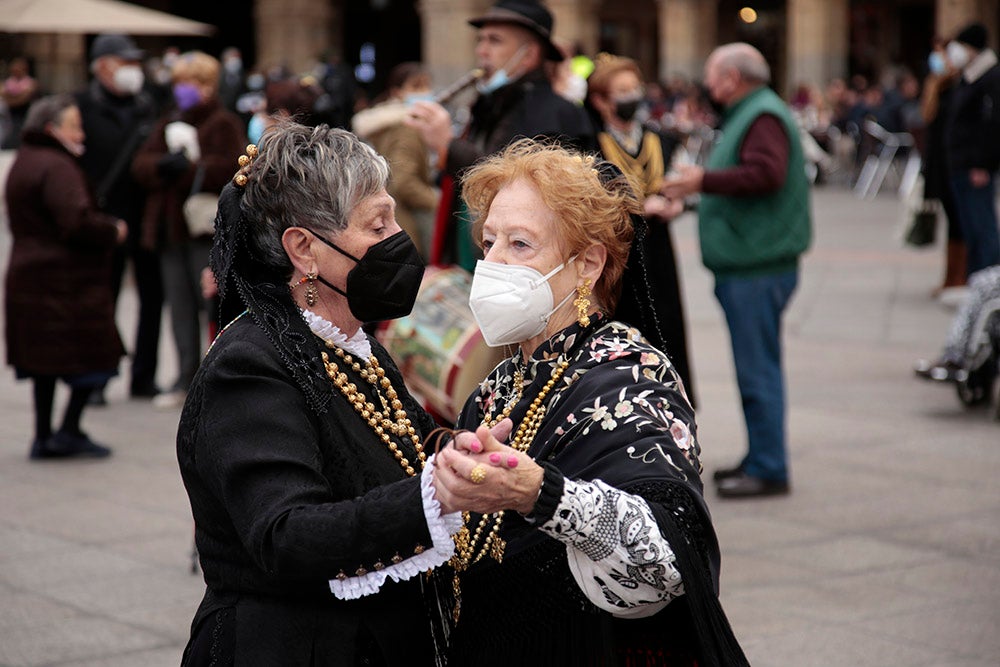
top-left (540, 479), bottom-right (684, 618)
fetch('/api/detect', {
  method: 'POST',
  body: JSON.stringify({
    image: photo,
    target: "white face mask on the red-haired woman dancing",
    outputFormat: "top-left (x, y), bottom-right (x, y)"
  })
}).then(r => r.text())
top-left (469, 256), bottom-right (575, 347)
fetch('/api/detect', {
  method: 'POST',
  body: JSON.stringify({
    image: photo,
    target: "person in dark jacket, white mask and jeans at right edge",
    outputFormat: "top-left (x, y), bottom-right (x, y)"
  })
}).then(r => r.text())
top-left (944, 23), bottom-right (1000, 275)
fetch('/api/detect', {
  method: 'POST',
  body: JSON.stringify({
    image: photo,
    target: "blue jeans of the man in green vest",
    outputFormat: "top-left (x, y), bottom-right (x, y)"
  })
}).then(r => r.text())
top-left (715, 271), bottom-right (799, 481)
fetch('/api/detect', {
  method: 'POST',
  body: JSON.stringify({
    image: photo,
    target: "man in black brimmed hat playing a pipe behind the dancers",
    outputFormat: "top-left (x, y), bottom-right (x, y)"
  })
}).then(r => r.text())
top-left (407, 0), bottom-right (596, 270)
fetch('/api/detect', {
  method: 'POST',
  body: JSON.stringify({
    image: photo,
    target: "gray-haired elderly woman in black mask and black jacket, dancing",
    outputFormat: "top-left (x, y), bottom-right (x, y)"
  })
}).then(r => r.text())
top-left (177, 122), bottom-right (461, 665)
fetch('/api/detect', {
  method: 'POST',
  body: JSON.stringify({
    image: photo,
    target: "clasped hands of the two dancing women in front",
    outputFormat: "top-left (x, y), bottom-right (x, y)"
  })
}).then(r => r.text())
top-left (434, 419), bottom-right (543, 514)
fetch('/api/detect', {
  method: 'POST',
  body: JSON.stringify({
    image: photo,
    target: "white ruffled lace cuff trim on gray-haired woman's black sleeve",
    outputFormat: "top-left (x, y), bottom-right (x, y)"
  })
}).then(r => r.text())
top-left (330, 455), bottom-right (462, 600)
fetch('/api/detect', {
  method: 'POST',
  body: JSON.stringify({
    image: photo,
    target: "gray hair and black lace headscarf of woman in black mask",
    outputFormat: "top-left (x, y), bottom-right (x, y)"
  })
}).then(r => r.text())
top-left (210, 122), bottom-right (389, 414)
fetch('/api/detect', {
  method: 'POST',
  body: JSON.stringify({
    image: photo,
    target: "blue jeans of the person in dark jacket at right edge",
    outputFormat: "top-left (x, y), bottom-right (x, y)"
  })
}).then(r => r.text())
top-left (951, 169), bottom-right (1000, 276)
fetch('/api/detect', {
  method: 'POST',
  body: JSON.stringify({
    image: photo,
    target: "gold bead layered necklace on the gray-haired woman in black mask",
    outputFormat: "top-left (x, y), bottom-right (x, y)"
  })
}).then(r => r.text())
top-left (321, 342), bottom-right (427, 477)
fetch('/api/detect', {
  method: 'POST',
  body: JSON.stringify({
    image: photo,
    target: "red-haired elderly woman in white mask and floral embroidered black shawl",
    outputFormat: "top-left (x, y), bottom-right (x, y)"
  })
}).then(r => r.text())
top-left (426, 140), bottom-right (746, 667)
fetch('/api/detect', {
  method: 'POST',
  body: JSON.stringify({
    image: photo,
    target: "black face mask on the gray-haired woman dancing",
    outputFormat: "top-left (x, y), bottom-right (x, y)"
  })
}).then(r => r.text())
top-left (313, 231), bottom-right (424, 322)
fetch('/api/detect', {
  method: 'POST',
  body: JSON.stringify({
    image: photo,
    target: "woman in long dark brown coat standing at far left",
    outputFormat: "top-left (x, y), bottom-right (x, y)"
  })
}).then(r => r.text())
top-left (5, 95), bottom-right (127, 459)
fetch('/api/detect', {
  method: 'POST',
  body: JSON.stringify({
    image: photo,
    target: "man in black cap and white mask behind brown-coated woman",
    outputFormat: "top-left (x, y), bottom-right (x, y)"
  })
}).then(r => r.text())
top-left (76, 34), bottom-right (163, 403)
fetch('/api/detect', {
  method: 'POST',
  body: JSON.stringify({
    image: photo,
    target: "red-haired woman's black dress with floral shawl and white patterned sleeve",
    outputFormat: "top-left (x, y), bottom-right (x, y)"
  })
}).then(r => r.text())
top-left (449, 318), bottom-right (745, 667)
